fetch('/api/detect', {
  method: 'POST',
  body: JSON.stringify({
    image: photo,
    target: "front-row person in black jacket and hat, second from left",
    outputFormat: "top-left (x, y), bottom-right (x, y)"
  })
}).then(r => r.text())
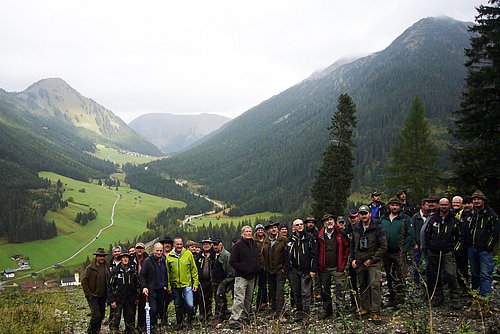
top-left (108, 253), bottom-right (140, 334)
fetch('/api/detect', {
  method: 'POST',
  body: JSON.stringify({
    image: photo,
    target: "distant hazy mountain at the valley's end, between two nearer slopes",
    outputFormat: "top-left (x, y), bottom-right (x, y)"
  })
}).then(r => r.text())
top-left (129, 113), bottom-right (231, 154)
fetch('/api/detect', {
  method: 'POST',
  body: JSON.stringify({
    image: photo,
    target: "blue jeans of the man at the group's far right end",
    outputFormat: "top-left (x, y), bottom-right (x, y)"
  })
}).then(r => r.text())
top-left (467, 247), bottom-right (494, 297)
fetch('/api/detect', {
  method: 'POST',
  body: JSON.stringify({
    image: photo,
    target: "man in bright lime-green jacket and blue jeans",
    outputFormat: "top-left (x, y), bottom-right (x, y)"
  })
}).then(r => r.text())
top-left (167, 238), bottom-right (199, 330)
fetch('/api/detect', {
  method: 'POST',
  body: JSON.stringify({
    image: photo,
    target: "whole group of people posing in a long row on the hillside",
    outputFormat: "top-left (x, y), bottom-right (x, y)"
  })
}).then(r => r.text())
top-left (82, 190), bottom-right (500, 333)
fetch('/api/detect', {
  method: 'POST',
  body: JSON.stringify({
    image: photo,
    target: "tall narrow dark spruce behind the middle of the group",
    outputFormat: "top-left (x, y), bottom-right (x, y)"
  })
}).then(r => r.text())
top-left (311, 93), bottom-right (357, 219)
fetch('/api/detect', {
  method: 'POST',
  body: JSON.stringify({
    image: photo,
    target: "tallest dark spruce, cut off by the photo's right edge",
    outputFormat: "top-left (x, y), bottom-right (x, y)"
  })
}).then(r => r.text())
top-left (452, 0), bottom-right (500, 209)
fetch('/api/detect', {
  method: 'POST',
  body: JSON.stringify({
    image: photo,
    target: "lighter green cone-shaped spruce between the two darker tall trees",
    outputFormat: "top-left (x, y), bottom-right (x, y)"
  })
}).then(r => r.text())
top-left (385, 95), bottom-right (439, 200)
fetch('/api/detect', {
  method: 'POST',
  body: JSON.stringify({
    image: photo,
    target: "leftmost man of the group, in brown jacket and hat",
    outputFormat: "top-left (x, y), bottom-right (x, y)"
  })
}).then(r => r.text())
top-left (82, 248), bottom-right (110, 334)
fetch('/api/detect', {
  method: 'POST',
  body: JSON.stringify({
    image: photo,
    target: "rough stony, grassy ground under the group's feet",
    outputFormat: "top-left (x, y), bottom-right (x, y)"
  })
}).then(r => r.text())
top-left (0, 288), bottom-right (500, 334)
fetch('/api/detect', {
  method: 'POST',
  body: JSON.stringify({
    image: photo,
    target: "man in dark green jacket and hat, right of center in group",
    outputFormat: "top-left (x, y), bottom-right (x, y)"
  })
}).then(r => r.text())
top-left (380, 197), bottom-right (415, 307)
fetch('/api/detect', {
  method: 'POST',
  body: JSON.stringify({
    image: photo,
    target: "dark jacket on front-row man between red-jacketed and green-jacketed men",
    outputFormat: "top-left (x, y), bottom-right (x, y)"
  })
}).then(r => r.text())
top-left (351, 219), bottom-right (387, 266)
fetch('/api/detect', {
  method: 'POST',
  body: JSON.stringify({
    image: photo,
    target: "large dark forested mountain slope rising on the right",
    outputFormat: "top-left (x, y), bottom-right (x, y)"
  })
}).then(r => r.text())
top-left (147, 17), bottom-right (470, 212)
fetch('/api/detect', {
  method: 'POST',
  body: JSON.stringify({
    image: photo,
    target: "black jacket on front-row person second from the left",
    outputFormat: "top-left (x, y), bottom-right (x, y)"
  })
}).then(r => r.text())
top-left (108, 264), bottom-right (139, 303)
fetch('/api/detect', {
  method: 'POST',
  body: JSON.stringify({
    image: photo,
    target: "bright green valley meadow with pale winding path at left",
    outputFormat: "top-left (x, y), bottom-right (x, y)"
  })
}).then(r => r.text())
top-left (0, 172), bottom-right (185, 271)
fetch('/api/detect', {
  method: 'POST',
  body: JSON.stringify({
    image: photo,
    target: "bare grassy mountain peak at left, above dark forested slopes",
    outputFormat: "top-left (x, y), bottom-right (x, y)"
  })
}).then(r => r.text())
top-left (9, 78), bottom-right (160, 155)
